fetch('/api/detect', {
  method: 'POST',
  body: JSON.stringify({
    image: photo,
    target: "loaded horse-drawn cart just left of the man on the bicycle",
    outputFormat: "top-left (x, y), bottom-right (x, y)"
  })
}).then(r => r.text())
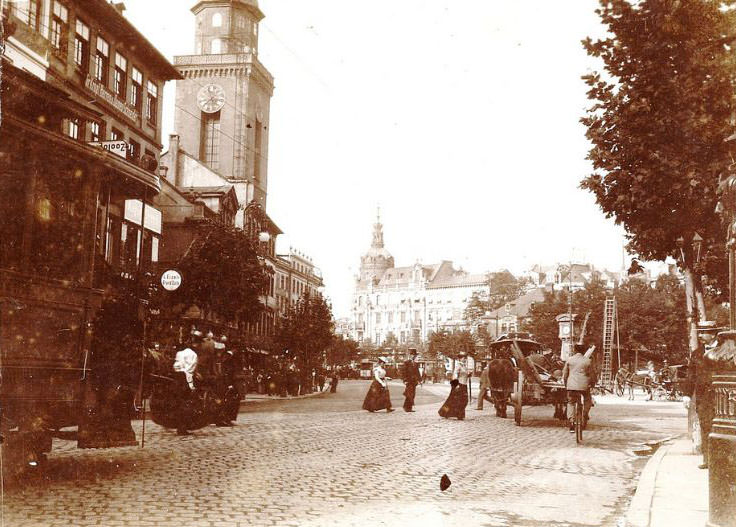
top-left (488, 334), bottom-right (566, 426)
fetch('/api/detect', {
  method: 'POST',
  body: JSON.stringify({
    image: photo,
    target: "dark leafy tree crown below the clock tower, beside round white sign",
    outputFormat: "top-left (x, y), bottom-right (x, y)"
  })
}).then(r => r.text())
top-left (173, 221), bottom-right (270, 322)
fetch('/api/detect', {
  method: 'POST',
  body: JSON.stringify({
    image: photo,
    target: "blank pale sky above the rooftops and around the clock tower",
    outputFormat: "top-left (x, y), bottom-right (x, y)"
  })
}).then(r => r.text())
top-left (119, 0), bottom-right (628, 317)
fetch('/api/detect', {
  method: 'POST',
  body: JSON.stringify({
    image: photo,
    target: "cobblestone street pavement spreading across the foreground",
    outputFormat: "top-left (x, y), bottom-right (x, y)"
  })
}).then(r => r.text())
top-left (2, 381), bottom-right (684, 527)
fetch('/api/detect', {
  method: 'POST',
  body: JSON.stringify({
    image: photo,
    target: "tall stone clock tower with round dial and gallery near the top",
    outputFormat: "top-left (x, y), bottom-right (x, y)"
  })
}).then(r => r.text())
top-left (174, 0), bottom-right (273, 220)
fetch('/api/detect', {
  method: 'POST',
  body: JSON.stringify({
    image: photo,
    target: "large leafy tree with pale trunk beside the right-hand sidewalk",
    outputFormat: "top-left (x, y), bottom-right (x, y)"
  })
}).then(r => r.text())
top-left (581, 0), bottom-right (736, 350)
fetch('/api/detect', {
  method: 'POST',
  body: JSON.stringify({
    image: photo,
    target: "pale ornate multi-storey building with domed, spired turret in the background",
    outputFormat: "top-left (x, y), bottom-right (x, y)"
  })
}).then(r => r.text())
top-left (349, 214), bottom-right (489, 346)
